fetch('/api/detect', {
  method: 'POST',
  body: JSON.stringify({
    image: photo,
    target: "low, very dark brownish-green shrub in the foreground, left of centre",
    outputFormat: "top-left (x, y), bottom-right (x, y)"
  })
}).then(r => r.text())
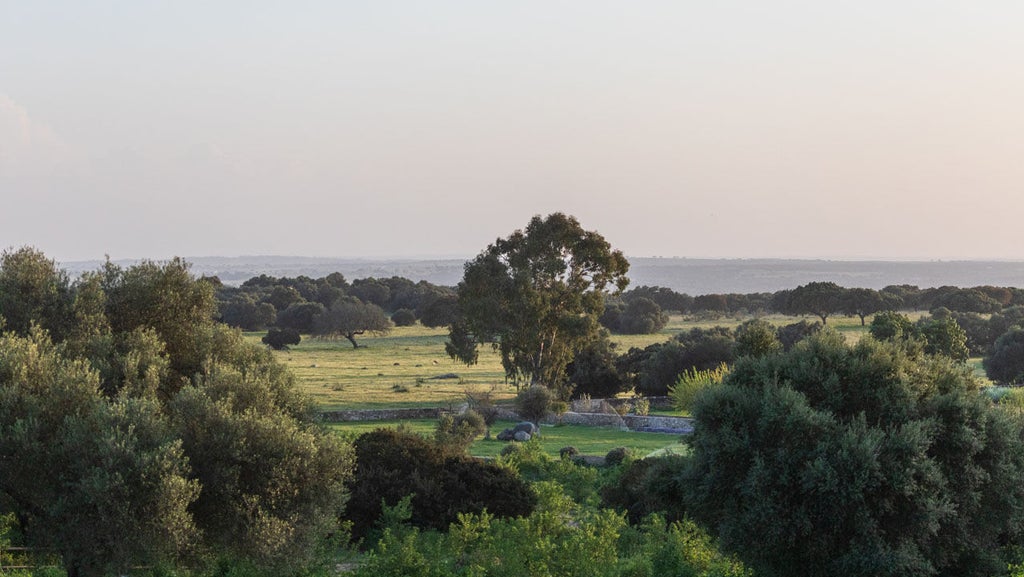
top-left (344, 428), bottom-right (537, 538)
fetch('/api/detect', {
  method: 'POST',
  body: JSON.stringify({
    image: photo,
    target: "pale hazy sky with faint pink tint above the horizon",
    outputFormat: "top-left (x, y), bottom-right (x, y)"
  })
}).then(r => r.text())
top-left (0, 0), bottom-right (1024, 260)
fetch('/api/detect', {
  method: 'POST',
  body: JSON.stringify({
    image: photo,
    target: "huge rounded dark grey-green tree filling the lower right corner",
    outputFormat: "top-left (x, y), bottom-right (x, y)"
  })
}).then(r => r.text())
top-left (686, 332), bottom-right (1024, 576)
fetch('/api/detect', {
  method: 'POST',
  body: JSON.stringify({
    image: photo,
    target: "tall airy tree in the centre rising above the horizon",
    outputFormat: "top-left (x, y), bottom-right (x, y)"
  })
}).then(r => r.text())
top-left (445, 213), bottom-right (629, 386)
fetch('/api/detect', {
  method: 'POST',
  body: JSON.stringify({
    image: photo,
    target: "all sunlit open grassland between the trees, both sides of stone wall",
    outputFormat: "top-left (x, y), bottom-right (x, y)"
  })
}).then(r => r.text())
top-left (262, 314), bottom-right (984, 457)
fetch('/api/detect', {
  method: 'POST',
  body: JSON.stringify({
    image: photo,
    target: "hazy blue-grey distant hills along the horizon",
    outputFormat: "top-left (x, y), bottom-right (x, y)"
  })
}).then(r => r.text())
top-left (61, 256), bottom-right (1024, 295)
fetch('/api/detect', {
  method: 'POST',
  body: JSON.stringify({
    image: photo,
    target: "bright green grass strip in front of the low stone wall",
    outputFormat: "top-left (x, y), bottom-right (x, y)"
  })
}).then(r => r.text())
top-left (330, 419), bottom-right (688, 457)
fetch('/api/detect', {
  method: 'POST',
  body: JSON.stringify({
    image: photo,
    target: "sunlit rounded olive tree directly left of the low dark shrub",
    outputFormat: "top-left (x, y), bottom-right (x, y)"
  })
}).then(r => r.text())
top-left (168, 333), bottom-right (353, 569)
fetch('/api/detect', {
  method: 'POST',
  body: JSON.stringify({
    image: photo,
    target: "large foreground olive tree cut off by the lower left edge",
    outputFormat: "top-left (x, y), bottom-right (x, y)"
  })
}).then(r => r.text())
top-left (0, 329), bottom-right (199, 575)
